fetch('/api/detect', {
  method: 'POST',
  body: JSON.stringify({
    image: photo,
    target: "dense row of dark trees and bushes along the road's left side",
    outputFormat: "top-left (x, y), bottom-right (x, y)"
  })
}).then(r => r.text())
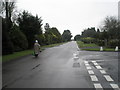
top-left (0, 0), bottom-right (72, 57)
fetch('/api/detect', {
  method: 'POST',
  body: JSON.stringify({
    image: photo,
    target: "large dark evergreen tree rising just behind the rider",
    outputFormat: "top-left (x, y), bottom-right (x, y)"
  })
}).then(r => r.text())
top-left (18, 11), bottom-right (42, 48)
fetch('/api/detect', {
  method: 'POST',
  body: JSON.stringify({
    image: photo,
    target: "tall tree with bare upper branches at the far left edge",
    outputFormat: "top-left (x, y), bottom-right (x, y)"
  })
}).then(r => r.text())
top-left (0, 0), bottom-right (15, 54)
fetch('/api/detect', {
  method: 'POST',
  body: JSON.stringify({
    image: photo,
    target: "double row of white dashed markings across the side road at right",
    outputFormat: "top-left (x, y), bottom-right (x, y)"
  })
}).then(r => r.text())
top-left (84, 61), bottom-right (120, 90)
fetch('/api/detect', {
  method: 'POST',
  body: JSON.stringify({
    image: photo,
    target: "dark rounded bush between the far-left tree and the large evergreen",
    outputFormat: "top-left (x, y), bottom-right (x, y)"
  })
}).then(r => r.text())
top-left (10, 25), bottom-right (28, 51)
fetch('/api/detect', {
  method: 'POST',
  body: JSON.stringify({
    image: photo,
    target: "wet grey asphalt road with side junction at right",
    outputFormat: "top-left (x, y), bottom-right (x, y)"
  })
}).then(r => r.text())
top-left (3, 41), bottom-right (119, 90)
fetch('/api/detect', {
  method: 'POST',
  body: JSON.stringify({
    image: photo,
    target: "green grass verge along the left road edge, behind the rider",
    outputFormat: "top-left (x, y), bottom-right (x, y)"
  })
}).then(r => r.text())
top-left (2, 42), bottom-right (65, 63)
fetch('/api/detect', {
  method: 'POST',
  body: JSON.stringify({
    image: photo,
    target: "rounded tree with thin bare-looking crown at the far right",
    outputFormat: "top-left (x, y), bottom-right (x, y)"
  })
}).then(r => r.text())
top-left (101, 16), bottom-right (120, 47)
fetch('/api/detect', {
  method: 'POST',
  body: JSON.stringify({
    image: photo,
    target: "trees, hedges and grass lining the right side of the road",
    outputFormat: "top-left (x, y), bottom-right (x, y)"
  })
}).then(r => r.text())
top-left (74, 16), bottom-right (120, 51)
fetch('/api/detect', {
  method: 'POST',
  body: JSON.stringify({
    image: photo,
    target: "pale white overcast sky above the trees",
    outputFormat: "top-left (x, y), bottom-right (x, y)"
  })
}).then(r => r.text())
top-left (17, 0), bottom-right (119, 36)
